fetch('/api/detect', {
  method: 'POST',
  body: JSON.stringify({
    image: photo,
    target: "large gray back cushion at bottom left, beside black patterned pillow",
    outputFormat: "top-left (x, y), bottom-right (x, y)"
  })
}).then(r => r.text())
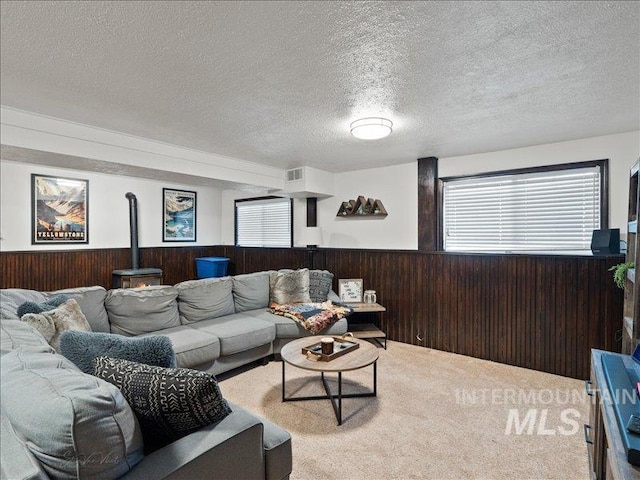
top-left (0, 349), bottom-right (143, 480)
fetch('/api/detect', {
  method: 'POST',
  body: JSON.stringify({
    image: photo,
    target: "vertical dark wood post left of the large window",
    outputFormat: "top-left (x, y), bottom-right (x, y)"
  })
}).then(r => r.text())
top-left (418, 157), bottom-right (438, 252)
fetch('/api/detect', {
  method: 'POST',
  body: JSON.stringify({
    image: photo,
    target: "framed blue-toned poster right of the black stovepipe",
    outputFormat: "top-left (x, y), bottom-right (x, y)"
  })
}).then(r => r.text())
top-left (162, 188), bottom-right (196, 242)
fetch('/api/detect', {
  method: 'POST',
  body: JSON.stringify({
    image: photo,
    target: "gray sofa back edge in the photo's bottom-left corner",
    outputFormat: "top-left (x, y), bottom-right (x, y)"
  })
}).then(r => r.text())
top-left (0, 413), bottom-right (49, 480)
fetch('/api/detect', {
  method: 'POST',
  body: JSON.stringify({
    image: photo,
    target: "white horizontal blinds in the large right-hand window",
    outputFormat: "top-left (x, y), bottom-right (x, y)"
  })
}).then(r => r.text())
top-left (443, 166), bottom-right (601, 252)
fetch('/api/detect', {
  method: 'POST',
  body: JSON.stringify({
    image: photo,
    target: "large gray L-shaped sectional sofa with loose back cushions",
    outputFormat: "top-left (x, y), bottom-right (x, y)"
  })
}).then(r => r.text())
top-left (0, 272), bottom-right (347, 480)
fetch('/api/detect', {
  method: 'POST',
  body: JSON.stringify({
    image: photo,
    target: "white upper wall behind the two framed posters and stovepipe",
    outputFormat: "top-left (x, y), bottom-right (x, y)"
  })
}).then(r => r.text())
top-left (0, 160), bottom-right (221, 252)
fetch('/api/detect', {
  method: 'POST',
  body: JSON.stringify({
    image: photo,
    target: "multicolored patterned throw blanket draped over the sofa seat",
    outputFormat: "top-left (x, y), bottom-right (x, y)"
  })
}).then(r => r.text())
top-left (269, 300), bottom-right (353, 335)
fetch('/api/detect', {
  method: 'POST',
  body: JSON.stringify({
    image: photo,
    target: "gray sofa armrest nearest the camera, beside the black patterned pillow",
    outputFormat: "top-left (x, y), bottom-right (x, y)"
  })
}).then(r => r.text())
top-left (122, 407), bottom-right (265, 480)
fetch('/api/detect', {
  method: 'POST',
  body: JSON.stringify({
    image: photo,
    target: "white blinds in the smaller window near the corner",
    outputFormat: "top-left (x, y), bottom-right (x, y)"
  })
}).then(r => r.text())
top-left (235, 198), bottom-right (292, 247)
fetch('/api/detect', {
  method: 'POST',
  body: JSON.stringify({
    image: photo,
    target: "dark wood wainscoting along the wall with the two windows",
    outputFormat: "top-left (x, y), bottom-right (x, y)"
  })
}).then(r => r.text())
top-left (214, 247), bottom-right (623, 379)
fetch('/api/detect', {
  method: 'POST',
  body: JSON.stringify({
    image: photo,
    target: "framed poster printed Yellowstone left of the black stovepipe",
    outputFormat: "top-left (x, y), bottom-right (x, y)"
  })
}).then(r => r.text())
top-left (31, 173), bottom-right (89, 245)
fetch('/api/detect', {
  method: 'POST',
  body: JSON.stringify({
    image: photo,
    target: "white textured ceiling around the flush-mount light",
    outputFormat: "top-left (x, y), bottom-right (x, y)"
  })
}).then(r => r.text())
top-left (0, 1), bottom-right (640, 172)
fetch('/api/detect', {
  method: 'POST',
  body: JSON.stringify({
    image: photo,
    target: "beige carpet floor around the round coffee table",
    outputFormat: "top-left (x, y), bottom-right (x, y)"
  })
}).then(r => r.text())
top-left (220, 342), bottom-right (589, 480)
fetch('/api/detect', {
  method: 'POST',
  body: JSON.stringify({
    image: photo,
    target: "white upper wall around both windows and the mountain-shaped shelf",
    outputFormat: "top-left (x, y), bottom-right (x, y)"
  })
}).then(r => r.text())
top-left (222, 132), bottom-right (640, 250)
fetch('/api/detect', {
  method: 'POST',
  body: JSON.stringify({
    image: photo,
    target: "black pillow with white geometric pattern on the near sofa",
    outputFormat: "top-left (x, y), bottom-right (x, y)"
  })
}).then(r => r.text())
top-left (93, 357), bottom-right (231, 453)
